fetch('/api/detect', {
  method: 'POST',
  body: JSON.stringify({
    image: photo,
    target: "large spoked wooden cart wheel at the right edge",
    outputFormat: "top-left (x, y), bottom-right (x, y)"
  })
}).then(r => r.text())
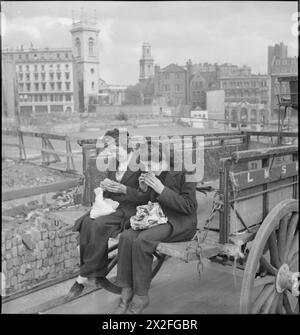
top-left (240, 199), bottom-right (299, 314)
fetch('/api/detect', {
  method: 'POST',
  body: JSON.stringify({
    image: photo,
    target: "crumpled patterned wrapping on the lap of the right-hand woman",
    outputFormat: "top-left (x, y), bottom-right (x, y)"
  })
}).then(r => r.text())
top-left (130, 201), bottom-right (168, 230)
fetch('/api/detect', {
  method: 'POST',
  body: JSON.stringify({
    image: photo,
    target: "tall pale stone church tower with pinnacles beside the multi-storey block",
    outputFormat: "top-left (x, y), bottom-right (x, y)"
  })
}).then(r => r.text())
top-left (70, 11), bottom-right (100, 113)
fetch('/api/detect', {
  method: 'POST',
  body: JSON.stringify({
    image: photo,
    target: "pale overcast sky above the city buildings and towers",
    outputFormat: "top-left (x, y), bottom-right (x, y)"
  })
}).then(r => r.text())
top-left (1, 1), bottom-right (298, 84)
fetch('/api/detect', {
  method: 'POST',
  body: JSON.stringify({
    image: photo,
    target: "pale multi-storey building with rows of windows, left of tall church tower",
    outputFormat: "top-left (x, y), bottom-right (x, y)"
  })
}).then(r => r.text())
top-left (3, 48), bottom-right (74, 115)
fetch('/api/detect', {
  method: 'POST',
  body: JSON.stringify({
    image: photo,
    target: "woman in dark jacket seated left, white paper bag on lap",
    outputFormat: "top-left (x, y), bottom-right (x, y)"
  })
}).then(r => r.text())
top-left (68, 129), bottom-right (140, 298)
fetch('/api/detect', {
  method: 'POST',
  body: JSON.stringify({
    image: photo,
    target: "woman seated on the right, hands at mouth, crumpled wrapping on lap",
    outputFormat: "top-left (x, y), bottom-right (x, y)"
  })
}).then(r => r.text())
top-left (115, 141), bottom-right (197, 314)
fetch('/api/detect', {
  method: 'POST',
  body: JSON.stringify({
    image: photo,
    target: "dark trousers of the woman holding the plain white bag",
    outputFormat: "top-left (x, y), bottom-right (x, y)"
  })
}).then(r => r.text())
top-left (80, 211), bottom-right (123, 278)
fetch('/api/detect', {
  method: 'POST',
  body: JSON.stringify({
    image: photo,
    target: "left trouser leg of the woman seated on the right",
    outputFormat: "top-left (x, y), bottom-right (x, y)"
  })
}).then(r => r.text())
top-left (117, 229), bottom-right (139, 287)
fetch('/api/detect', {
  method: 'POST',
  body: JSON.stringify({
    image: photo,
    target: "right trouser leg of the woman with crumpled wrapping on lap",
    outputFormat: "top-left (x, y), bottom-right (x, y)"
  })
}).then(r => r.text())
top-left (132, 224), bottom-right (172, 295)
